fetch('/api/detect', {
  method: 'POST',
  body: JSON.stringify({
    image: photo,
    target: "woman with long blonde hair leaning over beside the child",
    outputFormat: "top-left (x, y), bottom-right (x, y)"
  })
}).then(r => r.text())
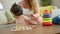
top-left (18, 0), bottom-right (42, 24)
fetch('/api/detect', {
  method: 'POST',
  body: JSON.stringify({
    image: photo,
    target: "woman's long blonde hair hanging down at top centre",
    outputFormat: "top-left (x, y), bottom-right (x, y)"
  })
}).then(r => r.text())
top-left (27, 0), bottom-right (38, 13)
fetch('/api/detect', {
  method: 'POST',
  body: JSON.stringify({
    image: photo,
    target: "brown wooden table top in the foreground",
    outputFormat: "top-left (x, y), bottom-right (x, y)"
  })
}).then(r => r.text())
top-left (0, 25), bottom-right (60, 34)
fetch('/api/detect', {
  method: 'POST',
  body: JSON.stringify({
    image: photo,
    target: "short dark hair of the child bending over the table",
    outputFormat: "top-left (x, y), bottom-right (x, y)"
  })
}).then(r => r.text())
top-left (10, 3), bottom-right (23, 16)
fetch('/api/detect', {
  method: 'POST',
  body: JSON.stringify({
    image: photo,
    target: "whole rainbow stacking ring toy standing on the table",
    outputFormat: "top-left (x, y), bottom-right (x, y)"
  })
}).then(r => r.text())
top-left (42, 10), bottom-right (52, 26)
